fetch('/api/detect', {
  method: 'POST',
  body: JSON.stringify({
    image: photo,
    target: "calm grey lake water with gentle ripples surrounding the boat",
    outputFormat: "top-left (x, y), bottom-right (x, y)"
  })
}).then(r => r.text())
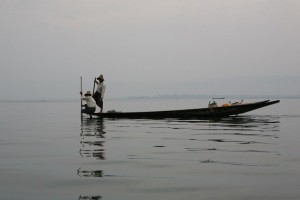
top-left (0, 99), bottom-right (300, 200)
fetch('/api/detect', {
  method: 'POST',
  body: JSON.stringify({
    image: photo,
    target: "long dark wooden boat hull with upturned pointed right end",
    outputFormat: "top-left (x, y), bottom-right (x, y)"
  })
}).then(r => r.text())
top-left (91, 100), bottom-right (280, 118)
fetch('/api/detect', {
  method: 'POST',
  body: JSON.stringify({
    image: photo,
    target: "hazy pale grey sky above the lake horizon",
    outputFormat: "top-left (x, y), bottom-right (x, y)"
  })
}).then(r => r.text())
top-left (0, 0), bottom-right (300, 100)
